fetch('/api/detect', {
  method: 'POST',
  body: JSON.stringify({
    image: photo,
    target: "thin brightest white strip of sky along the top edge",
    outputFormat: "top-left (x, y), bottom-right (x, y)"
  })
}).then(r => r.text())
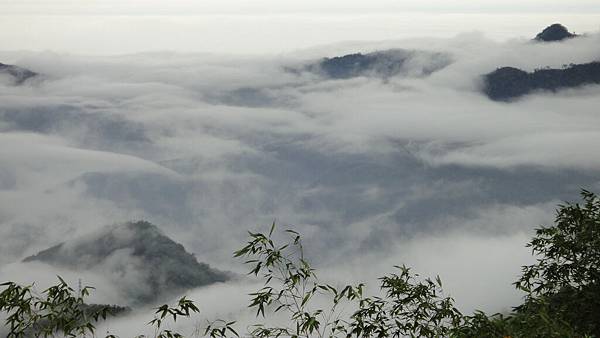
top-left (2, 0), bottom-right (600, 15)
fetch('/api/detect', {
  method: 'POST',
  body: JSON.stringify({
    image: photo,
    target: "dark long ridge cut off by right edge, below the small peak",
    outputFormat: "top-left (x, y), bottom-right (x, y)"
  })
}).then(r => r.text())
top-left (483, 62), bottom-right (600, 101)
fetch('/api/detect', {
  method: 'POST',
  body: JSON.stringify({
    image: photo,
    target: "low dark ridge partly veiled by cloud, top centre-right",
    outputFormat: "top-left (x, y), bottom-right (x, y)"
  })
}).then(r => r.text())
top-left (304, 49), bottom-right (451, 79)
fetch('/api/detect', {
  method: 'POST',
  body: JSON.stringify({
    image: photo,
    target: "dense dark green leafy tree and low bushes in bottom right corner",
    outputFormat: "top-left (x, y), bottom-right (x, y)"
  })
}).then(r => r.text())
top-left (456, 190), bottom-right (600, 338)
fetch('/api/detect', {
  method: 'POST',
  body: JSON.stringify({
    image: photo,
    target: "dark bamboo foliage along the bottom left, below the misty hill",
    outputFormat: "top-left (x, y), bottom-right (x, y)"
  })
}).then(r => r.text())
top-left (0, 277), bottom-right (237, 338)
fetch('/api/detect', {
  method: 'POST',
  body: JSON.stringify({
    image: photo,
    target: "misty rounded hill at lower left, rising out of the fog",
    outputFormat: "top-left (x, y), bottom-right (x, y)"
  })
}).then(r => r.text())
top-left (23, 221), bottom-right (229, 305)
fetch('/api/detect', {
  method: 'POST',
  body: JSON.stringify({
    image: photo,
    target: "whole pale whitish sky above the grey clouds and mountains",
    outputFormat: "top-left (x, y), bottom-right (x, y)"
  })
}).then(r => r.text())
top-left (0, 0), bottom-right (600, 54)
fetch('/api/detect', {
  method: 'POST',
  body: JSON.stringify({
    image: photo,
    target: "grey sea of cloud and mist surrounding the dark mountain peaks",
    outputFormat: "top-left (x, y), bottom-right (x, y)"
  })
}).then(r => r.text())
top-left (0, 15), bottom-right (600, 332)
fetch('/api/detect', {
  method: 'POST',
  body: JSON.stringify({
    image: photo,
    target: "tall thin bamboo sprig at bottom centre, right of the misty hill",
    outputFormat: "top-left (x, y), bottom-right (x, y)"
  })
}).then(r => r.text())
top-left (234, 224), bottom-right (352, 337)
